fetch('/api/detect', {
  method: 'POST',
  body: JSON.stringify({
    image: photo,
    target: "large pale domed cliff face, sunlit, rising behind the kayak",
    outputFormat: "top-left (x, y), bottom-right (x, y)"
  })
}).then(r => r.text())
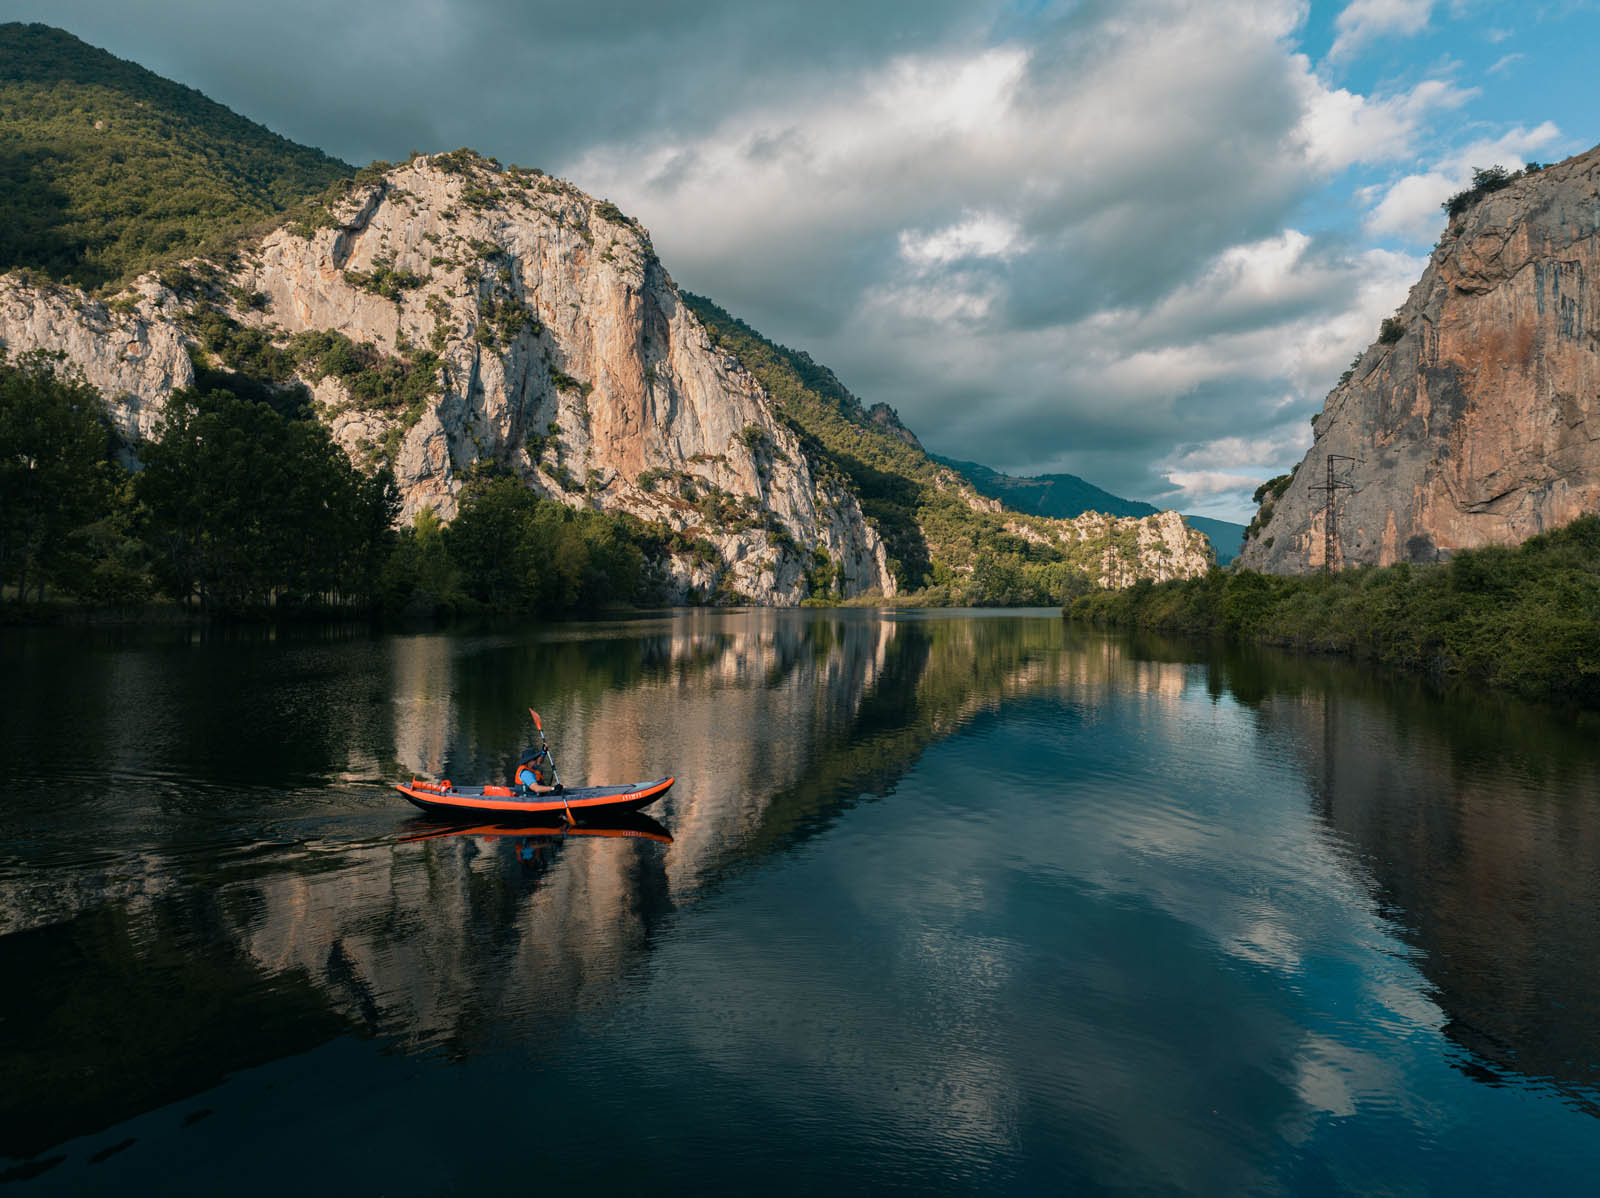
top-left (234, 155), bottom-right (894, 603)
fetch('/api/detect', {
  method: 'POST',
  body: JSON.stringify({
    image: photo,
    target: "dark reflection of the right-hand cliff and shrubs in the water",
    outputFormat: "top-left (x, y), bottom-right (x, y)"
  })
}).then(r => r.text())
top-left (1136, 638), bottom-right (1600, 1115)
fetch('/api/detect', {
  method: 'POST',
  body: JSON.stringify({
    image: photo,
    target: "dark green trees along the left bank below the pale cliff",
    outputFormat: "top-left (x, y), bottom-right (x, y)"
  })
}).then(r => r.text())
top-left (0, 350), bottom-right (693, 624)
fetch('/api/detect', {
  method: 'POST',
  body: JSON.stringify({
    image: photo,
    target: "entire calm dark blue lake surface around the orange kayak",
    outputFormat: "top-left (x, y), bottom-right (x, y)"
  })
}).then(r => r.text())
top-left (0, 611), bottom-right (1600, 1195)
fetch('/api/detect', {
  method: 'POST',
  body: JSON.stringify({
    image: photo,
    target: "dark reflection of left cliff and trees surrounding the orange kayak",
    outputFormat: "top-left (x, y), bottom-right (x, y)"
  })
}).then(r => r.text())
top-left (0, 611), bottom-right (1061, 1156)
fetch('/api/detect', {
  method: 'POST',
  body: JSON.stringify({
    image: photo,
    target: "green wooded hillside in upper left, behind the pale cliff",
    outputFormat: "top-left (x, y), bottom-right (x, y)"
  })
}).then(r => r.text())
top-left (0, 22), bottom-right (352, 288)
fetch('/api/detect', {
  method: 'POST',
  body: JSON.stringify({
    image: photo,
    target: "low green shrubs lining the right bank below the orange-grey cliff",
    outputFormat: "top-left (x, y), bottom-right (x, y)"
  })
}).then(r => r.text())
top-left (1067, 517), bottom-right (1600, 707)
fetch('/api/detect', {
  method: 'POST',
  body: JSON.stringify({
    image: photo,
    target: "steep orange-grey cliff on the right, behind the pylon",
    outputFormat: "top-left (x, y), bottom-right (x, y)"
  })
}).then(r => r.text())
top-left (1240, 149), bottom-right (1600, 573)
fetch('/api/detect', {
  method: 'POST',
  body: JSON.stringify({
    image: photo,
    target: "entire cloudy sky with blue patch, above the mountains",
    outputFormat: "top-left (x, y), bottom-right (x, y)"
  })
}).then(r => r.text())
top-left (12, 0), bottom-right (1600, 520)
